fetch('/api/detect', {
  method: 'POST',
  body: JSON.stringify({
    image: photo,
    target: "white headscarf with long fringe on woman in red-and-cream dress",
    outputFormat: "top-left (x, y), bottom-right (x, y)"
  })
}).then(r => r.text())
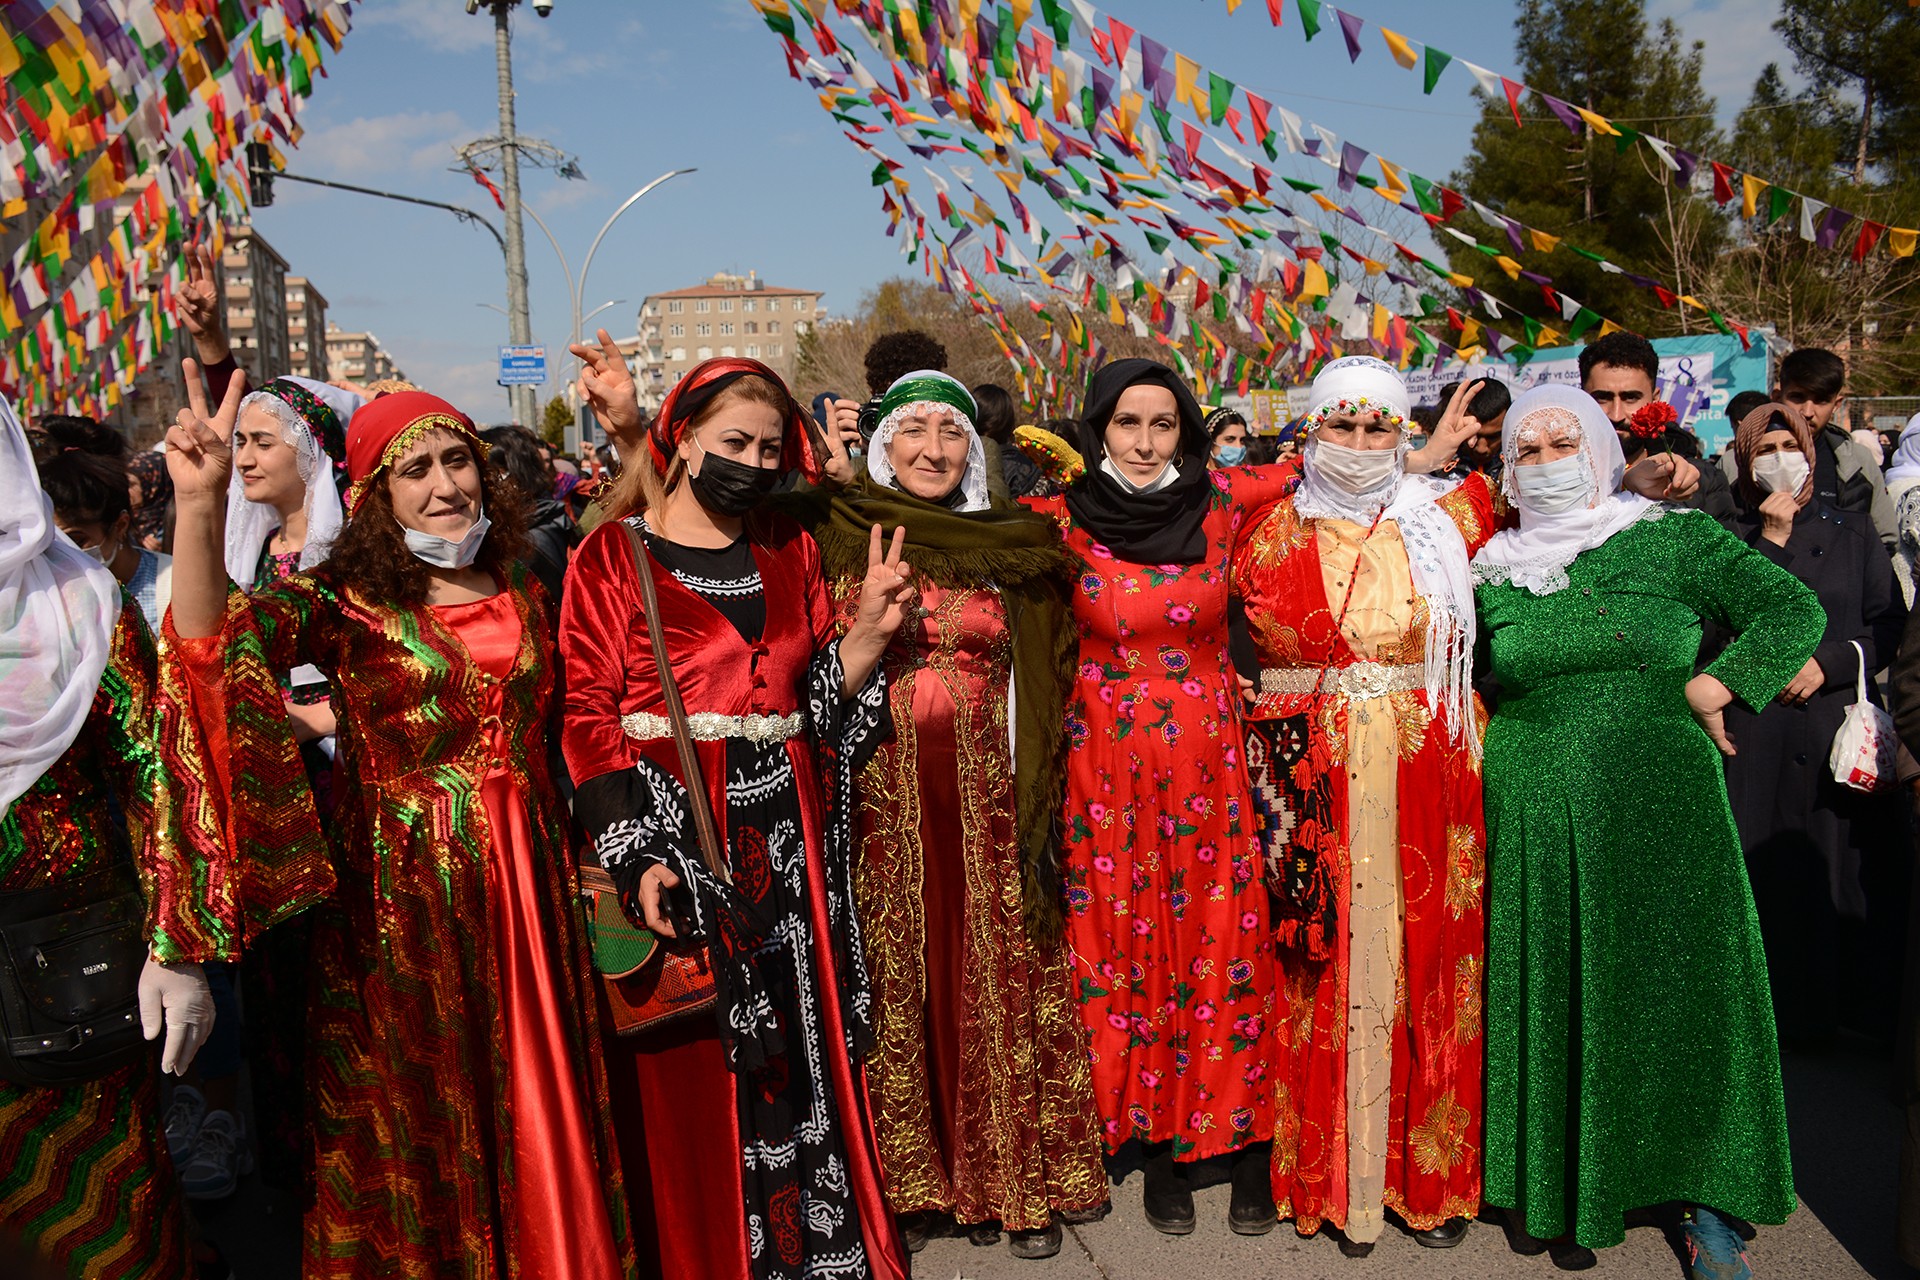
top-left (1294, 355), bottom-right (1480, 758)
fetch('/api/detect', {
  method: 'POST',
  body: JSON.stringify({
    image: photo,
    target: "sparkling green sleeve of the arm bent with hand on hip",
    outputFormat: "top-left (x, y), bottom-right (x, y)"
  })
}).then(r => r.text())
top-left (1681, 510), bottom-right (1826, 712)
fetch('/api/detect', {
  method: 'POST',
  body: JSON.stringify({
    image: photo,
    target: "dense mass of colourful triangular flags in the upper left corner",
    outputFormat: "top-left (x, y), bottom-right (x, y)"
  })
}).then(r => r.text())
top-left (0, 0), bottom-right (349, 415)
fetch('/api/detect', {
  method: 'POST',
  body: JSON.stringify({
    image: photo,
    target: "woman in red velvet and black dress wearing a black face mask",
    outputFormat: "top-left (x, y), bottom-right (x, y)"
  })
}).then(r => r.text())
top-left (561, 344), bottom-right (914, 1280)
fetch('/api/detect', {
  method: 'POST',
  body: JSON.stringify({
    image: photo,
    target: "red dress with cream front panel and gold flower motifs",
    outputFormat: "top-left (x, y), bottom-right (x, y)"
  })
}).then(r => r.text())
top-left (1233, 474), bottom-right (1496, 1242)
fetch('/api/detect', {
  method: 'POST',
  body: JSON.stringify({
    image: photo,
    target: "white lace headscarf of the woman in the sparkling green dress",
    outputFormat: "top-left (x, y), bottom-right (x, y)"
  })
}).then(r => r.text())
top-left (1473, 382), bottom-right (1667, 595)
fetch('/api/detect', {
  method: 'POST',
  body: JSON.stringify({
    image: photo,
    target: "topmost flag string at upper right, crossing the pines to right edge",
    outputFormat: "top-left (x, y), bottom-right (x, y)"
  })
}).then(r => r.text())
top-left (1213, 0), bottom-right (1920, 261)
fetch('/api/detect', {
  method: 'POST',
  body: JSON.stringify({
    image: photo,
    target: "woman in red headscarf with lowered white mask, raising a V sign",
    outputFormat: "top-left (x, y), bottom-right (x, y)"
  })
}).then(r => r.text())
top-left (167, 363), bottom-right (632, 1280)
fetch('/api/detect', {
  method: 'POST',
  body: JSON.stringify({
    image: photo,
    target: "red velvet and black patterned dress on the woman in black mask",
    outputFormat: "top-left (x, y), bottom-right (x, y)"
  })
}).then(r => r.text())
top-left (561, 520), bottom-right (906, 1280)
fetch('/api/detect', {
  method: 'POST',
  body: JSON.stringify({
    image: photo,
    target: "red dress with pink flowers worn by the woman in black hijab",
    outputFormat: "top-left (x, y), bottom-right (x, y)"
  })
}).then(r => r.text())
top-left (1027, 468), bottom-right (1290, 1161)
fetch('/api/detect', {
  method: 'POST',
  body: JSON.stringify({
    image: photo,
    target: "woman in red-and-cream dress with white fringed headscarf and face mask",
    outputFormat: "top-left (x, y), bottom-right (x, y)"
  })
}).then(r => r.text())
top-left (1233, 357), bottom-right (1496, 1257)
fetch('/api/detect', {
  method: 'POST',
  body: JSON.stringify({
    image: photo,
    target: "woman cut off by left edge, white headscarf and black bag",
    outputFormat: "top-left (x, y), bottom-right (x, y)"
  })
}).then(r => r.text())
top-left (0, 399), bottom-right (220, 1280)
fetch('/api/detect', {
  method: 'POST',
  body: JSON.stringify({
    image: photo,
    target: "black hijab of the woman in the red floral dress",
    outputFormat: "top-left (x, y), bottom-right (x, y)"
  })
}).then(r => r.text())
top-left (1068, 359), bottom-right (1213, 564)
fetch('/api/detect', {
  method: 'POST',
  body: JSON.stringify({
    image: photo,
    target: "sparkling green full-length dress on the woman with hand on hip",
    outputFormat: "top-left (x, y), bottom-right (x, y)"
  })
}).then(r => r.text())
top-left (1478, 510), bottom-right (1824, 1247)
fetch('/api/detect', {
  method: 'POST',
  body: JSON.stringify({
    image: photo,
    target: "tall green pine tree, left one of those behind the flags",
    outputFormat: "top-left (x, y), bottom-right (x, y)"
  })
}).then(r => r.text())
top-left (1440, 0), bottom-right (1728, 336)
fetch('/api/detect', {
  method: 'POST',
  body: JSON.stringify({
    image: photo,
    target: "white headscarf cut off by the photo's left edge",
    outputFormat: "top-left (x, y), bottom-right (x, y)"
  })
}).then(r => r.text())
top-left (0, 397), bottom-right (123, 819)
